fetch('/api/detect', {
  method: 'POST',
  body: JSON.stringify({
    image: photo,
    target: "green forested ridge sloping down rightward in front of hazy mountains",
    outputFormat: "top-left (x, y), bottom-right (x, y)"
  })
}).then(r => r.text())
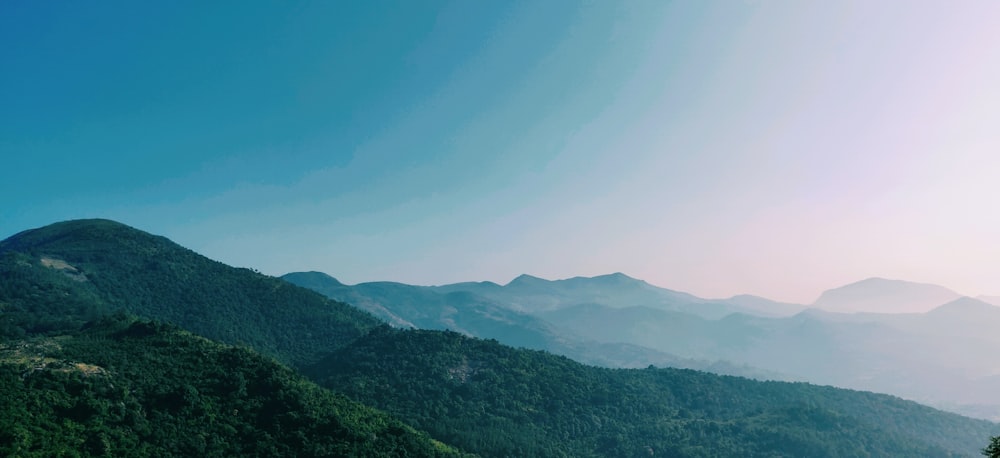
top-left (309, 326), bottom-right (998, 457)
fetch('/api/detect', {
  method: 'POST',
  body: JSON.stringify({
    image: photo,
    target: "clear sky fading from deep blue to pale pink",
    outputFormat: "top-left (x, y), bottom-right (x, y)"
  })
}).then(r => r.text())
top-left (0, 0), bottom-right (1000, 303)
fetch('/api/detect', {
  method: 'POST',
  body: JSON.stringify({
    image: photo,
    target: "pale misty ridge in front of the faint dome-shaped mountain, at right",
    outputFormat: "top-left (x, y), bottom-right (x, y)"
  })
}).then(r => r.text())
top-left (539, 298), bottom-right (1000, 419)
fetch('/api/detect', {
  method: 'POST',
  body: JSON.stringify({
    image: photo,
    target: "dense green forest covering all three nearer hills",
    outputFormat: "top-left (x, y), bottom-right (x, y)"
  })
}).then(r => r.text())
top-left (0, 220), bottom-right (1000, 457)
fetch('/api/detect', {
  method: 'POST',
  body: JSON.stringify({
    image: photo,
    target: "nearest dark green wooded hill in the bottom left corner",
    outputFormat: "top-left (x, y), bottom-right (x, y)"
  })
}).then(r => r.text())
top-left (0, 315), bottom-right (459, 457)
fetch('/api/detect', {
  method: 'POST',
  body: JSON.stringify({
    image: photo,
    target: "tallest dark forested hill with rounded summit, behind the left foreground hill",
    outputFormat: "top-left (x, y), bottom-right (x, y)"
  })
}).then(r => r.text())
top-left (0, 219), bottom-right (379, 367)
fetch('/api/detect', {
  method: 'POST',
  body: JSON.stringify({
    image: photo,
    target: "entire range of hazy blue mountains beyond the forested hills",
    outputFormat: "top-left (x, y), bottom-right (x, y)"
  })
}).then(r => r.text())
top-left (283, 272), bottom-right (1000, 419)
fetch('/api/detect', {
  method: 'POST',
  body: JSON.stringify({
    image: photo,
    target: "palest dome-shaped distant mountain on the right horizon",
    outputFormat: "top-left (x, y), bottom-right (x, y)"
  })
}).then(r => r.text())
top-left (812, 278), bottom-right (961, 313)
